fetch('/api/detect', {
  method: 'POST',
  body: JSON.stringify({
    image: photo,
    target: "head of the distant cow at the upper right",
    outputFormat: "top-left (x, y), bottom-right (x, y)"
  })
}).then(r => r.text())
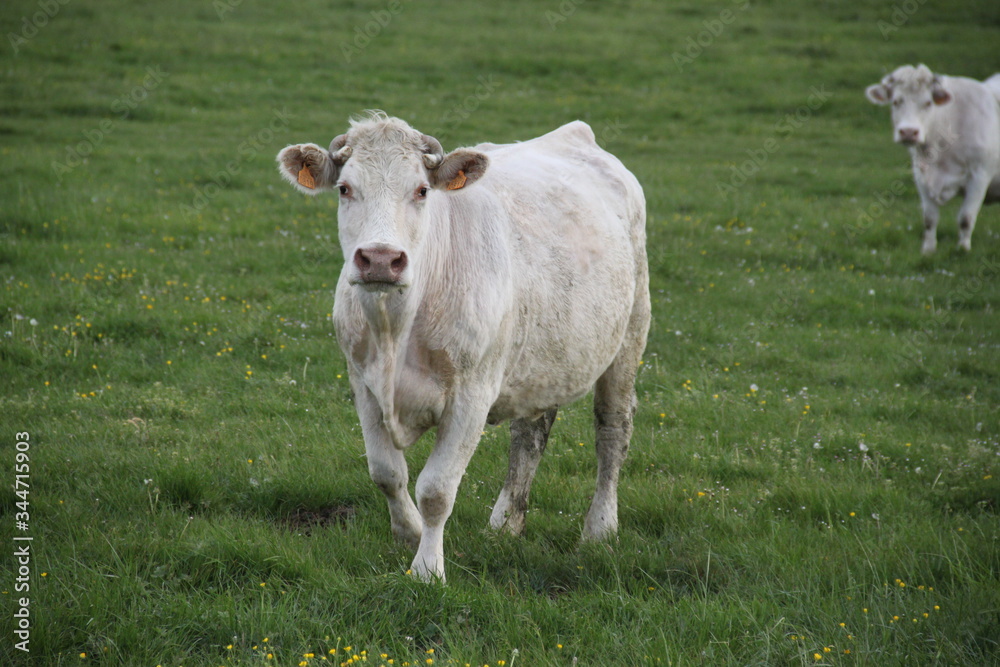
top-left (865, 65), bottom-right (951, 146)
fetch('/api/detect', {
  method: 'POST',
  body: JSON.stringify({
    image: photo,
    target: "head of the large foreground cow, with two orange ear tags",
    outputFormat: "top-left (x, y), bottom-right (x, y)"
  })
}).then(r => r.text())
top-left (278, 113), bottom-right (489, 291)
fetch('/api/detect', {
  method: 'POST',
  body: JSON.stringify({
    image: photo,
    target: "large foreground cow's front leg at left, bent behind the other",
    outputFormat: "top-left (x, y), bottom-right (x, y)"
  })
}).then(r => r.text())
top-left (355, 389), bottom-right (421, 550)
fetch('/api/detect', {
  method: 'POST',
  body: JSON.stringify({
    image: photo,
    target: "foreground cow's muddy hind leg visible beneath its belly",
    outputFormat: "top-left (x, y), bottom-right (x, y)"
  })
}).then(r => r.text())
top-left (490, 408), bottom-right (556, 535)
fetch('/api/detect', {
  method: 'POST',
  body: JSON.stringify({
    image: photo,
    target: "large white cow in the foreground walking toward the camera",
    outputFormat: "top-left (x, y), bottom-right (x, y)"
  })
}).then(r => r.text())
top-left (278, 112), bottom-right (650, 580)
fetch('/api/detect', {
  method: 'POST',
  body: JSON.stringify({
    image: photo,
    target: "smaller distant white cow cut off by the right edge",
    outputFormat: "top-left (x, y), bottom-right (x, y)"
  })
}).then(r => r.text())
top-left (865, 65), bottom-right (1000, 254)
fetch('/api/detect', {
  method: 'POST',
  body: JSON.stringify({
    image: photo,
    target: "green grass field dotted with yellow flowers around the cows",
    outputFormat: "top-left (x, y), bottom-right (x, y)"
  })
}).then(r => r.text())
top-left (0, 0), bottom-right (1000, 667)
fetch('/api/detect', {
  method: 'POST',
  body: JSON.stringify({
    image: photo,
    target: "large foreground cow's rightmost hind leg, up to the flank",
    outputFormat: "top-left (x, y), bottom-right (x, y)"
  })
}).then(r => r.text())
top-left (583, 284), bottom-right (650, 540)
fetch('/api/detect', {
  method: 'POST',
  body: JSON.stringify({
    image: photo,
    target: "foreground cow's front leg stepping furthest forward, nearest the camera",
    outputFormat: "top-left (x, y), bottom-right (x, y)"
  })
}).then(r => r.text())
top-left (410, 398), bottom-right (490, 582)
